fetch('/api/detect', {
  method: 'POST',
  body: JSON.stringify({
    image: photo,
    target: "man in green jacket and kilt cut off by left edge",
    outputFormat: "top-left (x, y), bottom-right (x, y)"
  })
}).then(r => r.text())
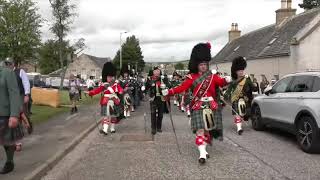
top-left (0, 61), bottom-right (22, 174)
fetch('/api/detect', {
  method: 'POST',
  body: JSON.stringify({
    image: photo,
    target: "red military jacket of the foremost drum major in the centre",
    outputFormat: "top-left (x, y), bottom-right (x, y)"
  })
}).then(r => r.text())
top-left (169, 73), bottom-right (227, 109)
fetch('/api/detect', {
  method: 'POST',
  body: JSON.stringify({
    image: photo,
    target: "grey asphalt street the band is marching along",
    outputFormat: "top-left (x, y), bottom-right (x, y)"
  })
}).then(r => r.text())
top-left (42, 103), bottom-right (320, 180)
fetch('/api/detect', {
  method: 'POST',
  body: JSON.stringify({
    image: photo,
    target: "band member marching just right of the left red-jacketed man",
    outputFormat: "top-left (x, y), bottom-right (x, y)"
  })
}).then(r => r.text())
top-left (120, 66), bottom-right (134, 117)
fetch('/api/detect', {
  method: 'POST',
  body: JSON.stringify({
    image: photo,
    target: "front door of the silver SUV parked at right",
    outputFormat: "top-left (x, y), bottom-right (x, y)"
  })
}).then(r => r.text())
top-left (260, 76), bottom-right (292, 120)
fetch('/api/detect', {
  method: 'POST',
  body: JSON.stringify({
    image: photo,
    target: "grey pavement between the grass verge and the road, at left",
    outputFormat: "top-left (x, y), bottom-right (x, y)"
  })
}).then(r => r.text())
top-left (0, 102), bottom-right (98, 180)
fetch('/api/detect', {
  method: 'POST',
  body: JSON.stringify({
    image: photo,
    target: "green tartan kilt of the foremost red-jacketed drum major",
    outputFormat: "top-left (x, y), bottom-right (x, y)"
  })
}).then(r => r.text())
top-left (191, 106), bottom-right (223, 132)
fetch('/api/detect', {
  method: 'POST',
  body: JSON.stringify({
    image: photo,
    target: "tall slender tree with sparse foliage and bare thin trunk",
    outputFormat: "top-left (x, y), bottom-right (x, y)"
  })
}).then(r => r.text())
top-left (49, 0), bottom-right (76, 89)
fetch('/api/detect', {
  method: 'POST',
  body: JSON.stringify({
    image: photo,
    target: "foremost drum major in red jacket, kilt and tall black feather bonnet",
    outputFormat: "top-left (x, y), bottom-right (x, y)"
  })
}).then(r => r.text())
top-left (162, 43), bottom-right (231, 164)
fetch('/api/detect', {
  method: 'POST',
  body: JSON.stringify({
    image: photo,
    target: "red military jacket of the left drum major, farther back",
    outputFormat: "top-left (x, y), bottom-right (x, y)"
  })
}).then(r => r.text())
top-left (89, 83), bottom-right (123, 105)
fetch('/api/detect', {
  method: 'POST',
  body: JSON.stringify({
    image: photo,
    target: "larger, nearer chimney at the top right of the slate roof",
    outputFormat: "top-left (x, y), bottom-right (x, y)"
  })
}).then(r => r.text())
top-left (276, 0), bottom-right (297, 26)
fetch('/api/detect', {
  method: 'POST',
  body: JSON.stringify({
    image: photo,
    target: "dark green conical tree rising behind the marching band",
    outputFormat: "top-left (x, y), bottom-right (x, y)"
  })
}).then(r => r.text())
top-left (113, 36), bottom-right (145, 72)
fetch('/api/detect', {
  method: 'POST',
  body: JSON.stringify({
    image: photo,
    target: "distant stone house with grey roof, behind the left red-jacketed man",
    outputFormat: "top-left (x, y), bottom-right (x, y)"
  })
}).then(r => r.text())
top-left (65, 54), bottom-right (112, 79)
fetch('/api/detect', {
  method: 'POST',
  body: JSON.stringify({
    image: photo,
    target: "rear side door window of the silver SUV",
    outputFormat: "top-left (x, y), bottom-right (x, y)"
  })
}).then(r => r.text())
top-left (289, 76), bottom-right (314, 92)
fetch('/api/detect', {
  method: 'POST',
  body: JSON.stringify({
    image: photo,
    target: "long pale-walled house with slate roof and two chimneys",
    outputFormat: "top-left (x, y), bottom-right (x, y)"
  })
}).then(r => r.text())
top-left (210, 0), bottom-right (320, 81)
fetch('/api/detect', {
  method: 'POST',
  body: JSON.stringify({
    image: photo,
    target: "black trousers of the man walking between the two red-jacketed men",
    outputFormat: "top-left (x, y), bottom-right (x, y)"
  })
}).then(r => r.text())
top-left (150, 97), bottom-right (165, 130)
